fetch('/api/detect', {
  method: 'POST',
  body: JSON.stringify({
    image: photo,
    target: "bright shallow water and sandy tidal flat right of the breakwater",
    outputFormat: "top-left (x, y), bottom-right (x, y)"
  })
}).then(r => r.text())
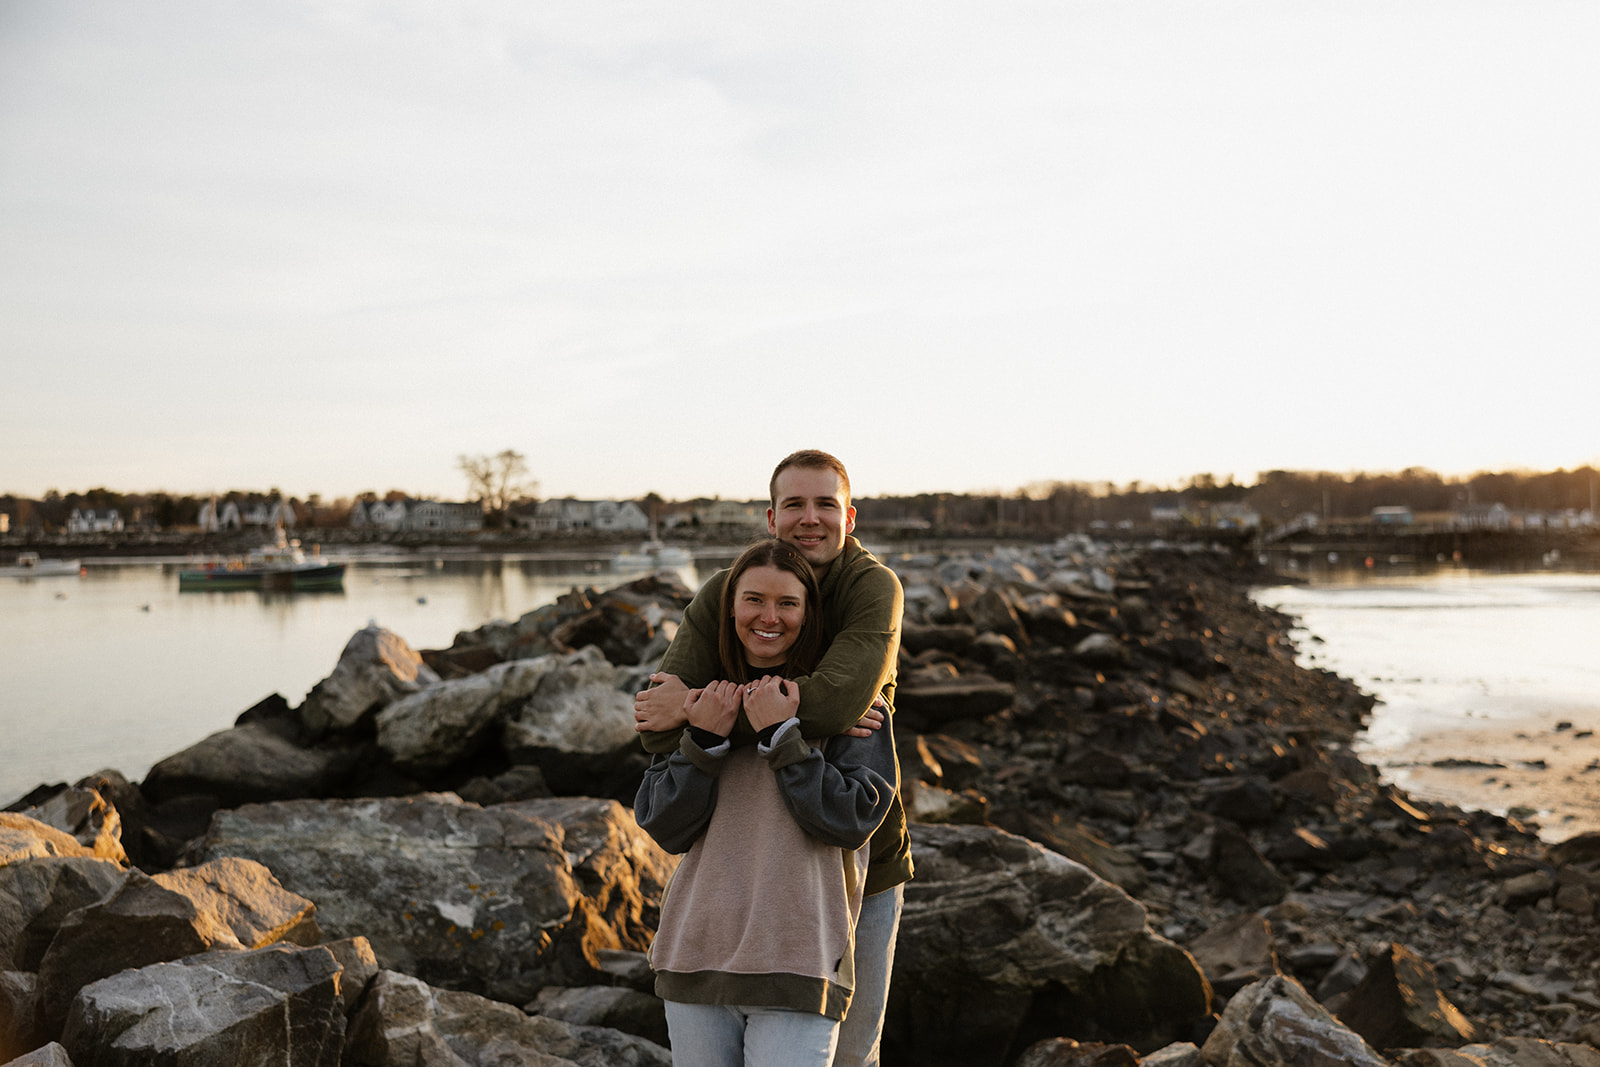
top-left (1256, 569), bottom-right (1600, 840)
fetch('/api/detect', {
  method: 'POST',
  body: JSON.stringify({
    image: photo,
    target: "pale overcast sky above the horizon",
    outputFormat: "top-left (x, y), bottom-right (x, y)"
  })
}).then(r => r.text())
top-left (0, 0), bottom-right (1600, 499)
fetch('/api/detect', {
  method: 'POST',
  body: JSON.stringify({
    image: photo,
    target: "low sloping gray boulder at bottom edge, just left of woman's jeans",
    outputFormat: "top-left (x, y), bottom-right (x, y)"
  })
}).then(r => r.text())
top-left (346, 971), bottom-right (672, 1067)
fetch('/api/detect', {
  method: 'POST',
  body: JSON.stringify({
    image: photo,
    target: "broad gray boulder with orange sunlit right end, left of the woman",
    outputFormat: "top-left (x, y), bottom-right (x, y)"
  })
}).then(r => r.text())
top-left (200, 793), bottom-right (672, 1005)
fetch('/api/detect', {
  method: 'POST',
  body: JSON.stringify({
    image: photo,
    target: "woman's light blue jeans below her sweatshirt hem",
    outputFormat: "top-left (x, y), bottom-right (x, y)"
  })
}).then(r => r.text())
top-left (666, 1000), bottom-right (838, 1067)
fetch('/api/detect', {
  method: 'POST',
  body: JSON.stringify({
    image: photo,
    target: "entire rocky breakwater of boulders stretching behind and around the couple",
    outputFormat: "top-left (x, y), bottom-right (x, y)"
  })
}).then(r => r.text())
top-left (0, 541), bottom-right (1600, 1067)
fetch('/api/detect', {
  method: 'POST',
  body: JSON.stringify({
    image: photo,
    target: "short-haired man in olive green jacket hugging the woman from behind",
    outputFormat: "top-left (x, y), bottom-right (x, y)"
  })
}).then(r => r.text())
top-left (634, 450), bottom-right (912, 1067)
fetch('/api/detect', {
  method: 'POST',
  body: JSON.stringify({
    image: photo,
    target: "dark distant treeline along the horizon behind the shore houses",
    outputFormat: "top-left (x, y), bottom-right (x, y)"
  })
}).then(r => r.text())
top-left (0, 466), bottom-right (1600, 536)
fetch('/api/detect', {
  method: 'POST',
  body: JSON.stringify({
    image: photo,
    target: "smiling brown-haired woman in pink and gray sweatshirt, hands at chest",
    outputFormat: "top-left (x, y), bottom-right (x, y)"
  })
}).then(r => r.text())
top-left (634, 539), bottom-right (899, 1067)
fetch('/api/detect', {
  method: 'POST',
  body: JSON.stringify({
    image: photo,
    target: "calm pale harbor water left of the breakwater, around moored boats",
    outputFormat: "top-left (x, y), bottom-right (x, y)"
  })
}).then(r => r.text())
top-left (0, 557), bottom-right (713, 806)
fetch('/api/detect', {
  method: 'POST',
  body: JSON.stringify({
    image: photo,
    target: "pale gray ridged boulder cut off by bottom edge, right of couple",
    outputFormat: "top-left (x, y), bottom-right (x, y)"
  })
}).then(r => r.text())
top-left (1200, 974), bottom-right (1389, 1067)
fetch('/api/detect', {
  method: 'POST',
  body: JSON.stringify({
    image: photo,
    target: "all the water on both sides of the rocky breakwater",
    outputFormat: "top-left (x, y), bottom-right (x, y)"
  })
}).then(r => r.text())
top-left (0, 552), bottom-right (1600, 840)
